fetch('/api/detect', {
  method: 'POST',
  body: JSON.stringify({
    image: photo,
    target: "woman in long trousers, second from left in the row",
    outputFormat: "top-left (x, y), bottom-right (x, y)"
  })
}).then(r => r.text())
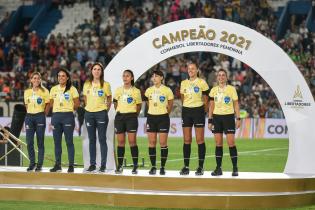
top-left (50, 68), bottom-right (80, 173)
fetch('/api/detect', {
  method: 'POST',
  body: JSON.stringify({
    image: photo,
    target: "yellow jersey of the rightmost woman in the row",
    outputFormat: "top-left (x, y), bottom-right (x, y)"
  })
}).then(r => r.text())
top-left (209, 85), bottom-right (238, 115)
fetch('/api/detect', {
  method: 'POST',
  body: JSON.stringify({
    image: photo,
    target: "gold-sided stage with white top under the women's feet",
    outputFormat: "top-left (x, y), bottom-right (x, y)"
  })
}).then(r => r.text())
top-left (0, 167), bottom-right (315, 209)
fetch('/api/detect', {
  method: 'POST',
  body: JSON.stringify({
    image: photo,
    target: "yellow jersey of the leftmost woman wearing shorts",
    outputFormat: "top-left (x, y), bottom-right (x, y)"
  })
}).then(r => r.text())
top-left (114, 86), bottom-right (142, 113)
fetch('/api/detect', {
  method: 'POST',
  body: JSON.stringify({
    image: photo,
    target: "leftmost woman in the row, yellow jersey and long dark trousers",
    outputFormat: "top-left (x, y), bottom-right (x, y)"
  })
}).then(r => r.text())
top-left (24, 72), bottom-right (49, 171)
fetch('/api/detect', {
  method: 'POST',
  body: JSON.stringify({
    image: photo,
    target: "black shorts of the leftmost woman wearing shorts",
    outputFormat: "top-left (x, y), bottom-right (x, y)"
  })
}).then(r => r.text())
top-left (114, 113), bottom-right (138, 134)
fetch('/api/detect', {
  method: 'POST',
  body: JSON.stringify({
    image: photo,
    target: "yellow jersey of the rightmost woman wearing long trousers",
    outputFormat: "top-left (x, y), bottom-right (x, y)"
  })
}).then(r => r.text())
top-left (83, 81), bottom-right (112, 112)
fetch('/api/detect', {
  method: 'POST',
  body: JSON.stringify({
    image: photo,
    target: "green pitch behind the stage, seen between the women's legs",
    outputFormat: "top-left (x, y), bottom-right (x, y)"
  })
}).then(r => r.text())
top-left (22, 137), bottom-right (289, 172)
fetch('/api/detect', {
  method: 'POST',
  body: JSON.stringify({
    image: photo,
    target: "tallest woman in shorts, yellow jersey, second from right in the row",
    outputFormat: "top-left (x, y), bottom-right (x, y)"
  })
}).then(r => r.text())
top-left (180, 63), bottom-right (209, 176)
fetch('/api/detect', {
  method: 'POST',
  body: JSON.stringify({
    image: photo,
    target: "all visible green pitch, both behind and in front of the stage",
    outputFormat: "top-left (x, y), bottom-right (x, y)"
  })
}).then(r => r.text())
top-left (4, 137), bottom-right (315, 210)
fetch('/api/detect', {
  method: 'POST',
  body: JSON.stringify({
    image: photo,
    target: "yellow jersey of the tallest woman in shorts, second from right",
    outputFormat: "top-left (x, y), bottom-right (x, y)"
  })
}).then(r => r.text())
top-left (180, 78), bottom-right (209, 108)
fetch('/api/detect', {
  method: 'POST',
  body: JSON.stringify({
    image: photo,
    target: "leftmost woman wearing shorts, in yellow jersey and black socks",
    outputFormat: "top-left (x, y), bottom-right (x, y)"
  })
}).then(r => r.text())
top-left (113, 70), bottom-right (142, 174)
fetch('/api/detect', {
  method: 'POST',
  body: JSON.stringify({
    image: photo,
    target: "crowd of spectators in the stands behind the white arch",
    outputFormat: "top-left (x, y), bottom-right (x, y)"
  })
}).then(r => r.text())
top-left (0, 0), bottom-right (315, 118)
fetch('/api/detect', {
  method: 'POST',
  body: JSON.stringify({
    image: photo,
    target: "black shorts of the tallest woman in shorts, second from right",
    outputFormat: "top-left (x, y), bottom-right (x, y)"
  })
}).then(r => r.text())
top-left (182, 106), bottom-right (205, 128)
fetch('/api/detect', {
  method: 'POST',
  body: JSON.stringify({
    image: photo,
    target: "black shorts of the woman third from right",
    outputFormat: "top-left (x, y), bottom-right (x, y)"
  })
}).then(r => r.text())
top-left (147, 114), bottom-right (170, 133)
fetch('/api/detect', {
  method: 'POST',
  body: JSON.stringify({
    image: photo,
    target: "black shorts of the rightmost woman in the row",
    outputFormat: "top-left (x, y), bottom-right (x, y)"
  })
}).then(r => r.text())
top-left (212, 114), bottom-right (235, 134)
